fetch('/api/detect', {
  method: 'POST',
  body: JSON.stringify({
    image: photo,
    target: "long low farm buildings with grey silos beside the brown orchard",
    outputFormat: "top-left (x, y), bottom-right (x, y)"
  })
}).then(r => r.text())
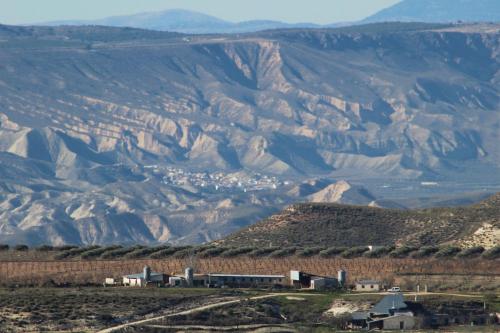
top-left (104, 266), bottom-right (346, 290)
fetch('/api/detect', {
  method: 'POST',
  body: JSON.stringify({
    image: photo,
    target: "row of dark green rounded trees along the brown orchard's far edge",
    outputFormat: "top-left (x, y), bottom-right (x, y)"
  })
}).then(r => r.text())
top-left (0, 245), bottom-right (500, 260)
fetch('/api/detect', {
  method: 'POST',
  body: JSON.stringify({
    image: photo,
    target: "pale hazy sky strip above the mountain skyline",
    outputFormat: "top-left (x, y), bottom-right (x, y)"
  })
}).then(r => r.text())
top-left (0, 0), bottom-right (400, 24)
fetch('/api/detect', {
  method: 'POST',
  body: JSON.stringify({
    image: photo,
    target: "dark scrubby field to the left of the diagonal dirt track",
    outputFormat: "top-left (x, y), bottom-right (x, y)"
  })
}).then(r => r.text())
top-left (0, 287), bottom-right (241, 333)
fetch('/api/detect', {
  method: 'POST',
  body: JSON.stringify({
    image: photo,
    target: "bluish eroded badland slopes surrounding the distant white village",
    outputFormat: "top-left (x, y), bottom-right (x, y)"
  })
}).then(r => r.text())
top-left (0, 23), bottom-right (500, 245)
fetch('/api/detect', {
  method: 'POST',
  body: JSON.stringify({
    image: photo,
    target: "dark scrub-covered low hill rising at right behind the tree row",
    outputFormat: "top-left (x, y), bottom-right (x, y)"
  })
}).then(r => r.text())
top-left (220, 194), bottom-right (500, 247)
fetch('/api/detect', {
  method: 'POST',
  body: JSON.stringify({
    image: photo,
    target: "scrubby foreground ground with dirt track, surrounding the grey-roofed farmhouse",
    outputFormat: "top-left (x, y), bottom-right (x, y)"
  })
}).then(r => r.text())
top-left (0, 287), bottom-right (500, 333)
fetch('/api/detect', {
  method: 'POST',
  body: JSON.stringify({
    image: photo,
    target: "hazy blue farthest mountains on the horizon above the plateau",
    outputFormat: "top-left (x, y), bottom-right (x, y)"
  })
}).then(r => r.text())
top-left (40, 0), bottom-right (500, 34)
